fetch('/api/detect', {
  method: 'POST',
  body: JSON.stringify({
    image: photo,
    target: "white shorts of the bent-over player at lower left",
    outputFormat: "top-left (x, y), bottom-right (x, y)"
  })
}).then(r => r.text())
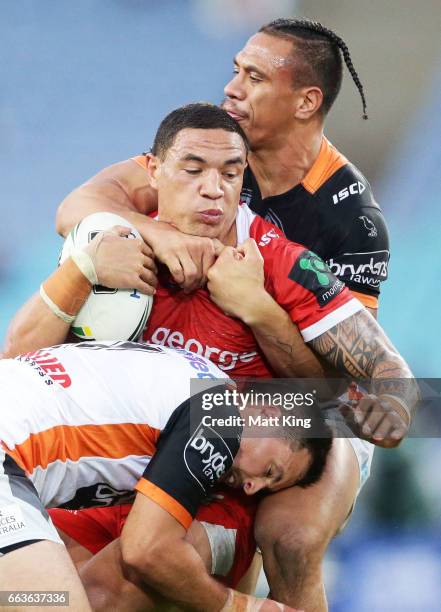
top-left (0, 448), bottom-right (63, 556)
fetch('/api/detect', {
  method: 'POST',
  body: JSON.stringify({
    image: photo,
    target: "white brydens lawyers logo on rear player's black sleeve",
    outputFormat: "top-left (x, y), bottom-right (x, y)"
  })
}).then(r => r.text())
top-left (327, 250), bottom-right (389, 289)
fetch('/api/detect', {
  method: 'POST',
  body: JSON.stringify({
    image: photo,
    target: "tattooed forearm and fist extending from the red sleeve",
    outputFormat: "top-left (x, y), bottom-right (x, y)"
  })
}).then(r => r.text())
top-left (310, 310), bottom-right (419, 447)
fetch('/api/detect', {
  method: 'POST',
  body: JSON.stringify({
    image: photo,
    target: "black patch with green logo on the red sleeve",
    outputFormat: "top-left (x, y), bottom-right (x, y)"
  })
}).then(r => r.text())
top-left (288, 250), bottom-right (344, 306)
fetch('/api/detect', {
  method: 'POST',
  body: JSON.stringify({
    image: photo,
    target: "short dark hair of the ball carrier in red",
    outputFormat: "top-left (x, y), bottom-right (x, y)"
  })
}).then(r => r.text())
top-left (151, 102), bottom-right (249, 158)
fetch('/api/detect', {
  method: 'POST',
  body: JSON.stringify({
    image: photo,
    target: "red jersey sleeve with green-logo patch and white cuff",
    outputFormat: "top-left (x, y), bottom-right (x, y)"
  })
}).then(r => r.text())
top-left (271, 241), bottom-right (363, 342)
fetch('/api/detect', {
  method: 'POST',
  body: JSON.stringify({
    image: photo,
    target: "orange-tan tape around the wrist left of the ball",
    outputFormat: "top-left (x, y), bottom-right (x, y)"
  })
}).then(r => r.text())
top-left (40, 257), bottom-right (92, 323)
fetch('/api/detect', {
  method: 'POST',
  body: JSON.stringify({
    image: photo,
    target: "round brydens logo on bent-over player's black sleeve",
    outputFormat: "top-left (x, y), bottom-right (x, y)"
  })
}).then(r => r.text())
top-left (184, 421), bottom-right (233, 491)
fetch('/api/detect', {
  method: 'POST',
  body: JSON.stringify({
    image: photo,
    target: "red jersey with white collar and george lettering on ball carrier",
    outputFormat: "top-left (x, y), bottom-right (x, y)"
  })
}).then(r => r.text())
top-left (143, 205), bottom-right (363, 376)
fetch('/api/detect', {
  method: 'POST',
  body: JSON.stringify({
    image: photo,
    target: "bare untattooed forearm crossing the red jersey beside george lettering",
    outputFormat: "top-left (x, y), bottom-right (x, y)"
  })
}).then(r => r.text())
top-left (243, 291), bottom-right (325, 378)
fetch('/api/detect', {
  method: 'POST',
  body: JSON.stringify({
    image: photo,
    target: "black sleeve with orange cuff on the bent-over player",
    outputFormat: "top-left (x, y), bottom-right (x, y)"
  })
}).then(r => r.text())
top-left (135, 391), bottom-right (241, 529)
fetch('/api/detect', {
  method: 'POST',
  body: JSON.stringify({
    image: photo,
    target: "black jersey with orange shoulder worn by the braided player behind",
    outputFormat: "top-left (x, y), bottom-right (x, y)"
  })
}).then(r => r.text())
top-left (237, 138), bottom-right (389, 308)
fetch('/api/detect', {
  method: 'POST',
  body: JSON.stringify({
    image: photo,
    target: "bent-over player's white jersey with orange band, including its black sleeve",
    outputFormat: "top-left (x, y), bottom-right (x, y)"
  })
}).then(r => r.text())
top-left (0, 342), bottom-right (235, 527)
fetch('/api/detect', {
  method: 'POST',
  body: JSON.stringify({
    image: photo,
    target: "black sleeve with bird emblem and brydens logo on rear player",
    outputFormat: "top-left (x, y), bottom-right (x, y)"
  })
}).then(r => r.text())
top-left (327, 206), bottom-right (390, 308)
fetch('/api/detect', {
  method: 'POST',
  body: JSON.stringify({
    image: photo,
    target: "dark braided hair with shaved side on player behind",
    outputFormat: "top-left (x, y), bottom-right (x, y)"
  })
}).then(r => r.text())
top-left (259, 18), bottom-right (368, 119)
